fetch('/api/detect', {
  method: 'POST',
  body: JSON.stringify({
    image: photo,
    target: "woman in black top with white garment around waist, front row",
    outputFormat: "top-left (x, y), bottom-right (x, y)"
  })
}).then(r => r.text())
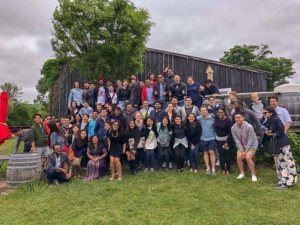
top-left (171, 116), bottom-right (188, 172)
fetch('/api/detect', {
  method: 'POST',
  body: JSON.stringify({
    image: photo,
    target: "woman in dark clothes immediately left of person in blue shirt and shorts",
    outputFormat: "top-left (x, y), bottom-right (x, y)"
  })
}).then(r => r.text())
top-left (186, 113), bottom-right (202, 173)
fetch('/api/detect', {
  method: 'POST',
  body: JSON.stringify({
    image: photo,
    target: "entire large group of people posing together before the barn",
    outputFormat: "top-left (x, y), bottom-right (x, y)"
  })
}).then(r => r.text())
top-left (13, 68), bottom-right (297, 190)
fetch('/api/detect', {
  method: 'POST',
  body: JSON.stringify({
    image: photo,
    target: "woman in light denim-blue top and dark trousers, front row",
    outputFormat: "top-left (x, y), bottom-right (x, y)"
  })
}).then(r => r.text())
top-left (157, 116), bottom-right (172, 170)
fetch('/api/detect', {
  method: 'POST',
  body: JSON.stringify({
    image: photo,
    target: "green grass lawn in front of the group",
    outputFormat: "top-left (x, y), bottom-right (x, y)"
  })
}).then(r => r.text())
top-left (0, 140), bottom-right (300, 225)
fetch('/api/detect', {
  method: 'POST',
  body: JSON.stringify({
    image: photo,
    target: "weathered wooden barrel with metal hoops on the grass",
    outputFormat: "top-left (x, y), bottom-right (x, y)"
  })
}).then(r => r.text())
top-left (6, 153), bottom-right (41, 186)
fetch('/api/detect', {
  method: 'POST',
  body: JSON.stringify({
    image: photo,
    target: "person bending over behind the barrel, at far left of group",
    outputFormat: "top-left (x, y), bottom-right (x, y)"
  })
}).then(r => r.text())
top-left (12, 128), bottom-right (31, 154)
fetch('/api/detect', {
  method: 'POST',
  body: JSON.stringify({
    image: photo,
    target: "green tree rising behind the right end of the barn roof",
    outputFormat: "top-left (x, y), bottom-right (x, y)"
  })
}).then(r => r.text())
top-left (220, 45), bottom-right (295, 90)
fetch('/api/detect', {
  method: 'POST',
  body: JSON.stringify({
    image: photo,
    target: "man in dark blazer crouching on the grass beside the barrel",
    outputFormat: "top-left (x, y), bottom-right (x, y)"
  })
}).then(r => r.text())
top-left (47, 144), bottom-right (72, 184)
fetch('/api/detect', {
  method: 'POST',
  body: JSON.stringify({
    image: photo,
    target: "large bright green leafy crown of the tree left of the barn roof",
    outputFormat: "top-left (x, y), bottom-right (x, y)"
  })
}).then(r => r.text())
top-left (51, 0), bottom-right (153, 79)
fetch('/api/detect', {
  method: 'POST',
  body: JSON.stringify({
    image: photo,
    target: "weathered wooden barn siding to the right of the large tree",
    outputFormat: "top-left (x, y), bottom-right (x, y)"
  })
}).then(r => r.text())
top-left (139, 49), bottom-right (271, 92)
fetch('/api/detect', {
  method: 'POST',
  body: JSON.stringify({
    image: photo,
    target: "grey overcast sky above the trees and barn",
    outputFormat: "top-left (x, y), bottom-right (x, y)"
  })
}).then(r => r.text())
top-left (0, 0), bottom-right (300, 101)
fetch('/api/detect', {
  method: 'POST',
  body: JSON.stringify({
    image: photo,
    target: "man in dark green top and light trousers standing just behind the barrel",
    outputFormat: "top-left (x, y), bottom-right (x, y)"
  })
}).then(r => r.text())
top-left (31, 114), bottom-right (50, 157)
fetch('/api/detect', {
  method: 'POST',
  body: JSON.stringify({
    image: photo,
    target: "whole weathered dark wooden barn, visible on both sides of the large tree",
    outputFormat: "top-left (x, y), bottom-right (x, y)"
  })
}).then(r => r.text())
top-left (51, 48), bottom-right (272, 116)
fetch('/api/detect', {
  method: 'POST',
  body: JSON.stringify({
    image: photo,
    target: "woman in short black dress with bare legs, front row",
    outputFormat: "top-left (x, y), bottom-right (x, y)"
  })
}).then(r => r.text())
top-left (108, 121), bottom-right (126, 180)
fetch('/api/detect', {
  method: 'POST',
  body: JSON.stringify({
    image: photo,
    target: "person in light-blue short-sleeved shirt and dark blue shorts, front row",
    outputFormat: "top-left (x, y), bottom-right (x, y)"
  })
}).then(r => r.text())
top-left (197, 107), bottom-right (217, 175)
